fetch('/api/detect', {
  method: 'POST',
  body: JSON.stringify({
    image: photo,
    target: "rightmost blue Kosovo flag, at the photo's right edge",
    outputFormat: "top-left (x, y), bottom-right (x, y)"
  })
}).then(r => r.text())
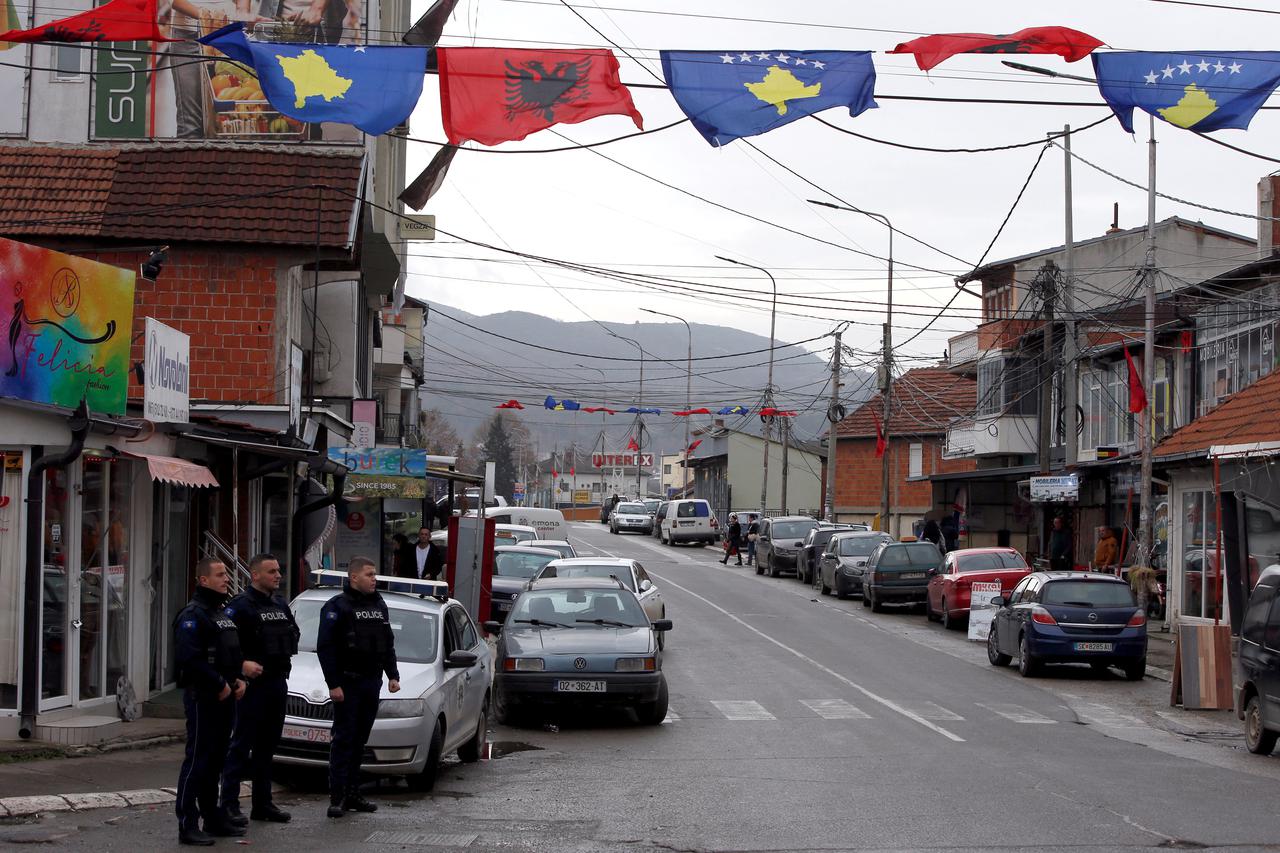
top-left (1093, 50), bottom-right (1280, 133)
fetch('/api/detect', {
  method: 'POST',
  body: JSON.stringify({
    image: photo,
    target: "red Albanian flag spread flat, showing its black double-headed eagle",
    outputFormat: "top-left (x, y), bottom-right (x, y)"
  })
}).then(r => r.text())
top-left (436, 47), bottom-right (644, 145)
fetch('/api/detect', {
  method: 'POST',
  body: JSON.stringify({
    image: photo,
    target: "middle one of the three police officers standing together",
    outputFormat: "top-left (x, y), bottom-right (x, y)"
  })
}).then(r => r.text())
top-left (223, 553), bottom-right (300, 826)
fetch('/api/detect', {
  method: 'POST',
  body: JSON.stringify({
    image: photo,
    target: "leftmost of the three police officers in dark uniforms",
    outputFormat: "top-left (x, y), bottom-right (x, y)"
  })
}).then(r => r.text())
top-left (174, 557), bottom-right (244, 847)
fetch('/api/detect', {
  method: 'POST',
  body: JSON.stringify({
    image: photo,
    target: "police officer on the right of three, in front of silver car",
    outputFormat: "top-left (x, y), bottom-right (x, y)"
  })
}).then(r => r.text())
top-left (316, 557), bottom-right (399, 817)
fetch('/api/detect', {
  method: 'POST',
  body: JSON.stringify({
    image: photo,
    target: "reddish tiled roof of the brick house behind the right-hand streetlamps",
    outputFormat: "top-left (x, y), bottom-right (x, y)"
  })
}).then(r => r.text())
top-left (836, 368), bottom-right (978, 438)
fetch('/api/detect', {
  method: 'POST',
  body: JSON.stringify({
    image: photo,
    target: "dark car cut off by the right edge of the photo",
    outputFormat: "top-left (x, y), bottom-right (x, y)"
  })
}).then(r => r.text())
top-left (1235, 565), bottom-right (1280, 756)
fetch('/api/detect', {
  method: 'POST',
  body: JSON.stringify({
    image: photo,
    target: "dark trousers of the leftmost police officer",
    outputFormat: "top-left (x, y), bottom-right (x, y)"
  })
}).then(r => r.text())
top-left (174, 686), bottom-right (236, 831)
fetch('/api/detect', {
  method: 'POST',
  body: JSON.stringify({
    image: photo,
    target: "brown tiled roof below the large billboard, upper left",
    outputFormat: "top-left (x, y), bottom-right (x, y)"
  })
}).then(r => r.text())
top-left (0, 145), bottom-right (364, 247)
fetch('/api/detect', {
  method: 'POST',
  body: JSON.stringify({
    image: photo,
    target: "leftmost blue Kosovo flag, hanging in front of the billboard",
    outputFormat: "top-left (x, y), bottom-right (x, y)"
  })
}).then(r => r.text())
top-left (198, 23), bottom-right (430, 136)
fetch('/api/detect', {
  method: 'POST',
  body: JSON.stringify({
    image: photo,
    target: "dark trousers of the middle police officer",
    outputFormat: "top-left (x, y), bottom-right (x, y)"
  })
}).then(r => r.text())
top-left (223, 675), bottom-right (288, 806)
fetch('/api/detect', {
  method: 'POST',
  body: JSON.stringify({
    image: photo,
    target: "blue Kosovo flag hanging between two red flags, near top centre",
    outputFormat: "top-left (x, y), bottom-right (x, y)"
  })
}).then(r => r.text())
top-left (662, 50), bottom-right (877, 146)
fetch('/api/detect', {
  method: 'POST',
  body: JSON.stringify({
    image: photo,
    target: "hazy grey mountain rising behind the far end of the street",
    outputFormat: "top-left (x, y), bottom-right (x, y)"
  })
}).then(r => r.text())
top-left (422, 305), bottom-right (874, 455)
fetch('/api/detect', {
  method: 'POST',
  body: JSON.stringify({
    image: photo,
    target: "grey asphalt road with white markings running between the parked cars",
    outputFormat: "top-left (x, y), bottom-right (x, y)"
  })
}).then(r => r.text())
top-left (15, 524), bottom-right (1280, 850)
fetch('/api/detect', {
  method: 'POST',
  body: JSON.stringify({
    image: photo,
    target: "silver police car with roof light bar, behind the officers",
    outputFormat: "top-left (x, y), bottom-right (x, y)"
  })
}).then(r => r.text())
top-left (275, 571), bottom-right (493, 789)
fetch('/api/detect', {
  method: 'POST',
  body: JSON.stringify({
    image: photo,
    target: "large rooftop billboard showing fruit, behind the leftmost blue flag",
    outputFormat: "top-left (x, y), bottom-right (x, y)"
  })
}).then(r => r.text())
top-left (92, 0), bottom-right (367, 143)
